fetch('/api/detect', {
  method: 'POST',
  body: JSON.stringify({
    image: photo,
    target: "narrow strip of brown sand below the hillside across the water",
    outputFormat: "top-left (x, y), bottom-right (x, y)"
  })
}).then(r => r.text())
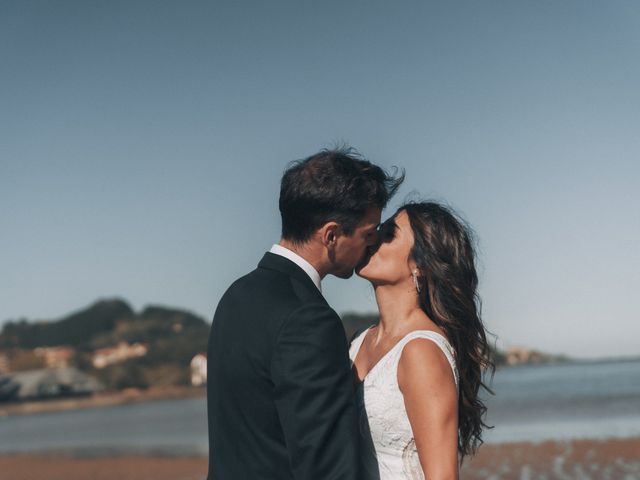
top-left (0, 386), bottom-right (207, 417)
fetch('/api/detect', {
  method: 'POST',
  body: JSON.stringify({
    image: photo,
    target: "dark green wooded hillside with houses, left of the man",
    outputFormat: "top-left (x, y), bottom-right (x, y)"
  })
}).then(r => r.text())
top-left (0, 299), bottom-right (209, 389)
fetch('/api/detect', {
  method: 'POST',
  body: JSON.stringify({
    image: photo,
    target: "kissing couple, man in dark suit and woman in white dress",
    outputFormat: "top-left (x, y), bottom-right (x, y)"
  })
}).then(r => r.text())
top-left (207, 148), bottom-right (492, 480)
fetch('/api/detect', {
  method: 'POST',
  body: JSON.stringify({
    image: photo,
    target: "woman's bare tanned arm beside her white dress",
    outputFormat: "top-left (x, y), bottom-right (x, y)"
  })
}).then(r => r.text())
top-left (398, 339), bottom-right (458, 480)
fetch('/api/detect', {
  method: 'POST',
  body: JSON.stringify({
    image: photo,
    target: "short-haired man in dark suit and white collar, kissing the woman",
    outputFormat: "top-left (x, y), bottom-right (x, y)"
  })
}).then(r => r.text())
top-left (207, 149), bottom-right (403, 480)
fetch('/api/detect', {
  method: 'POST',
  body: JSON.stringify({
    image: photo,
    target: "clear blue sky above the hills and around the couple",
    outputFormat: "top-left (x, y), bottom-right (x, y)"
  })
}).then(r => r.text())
top-left (0, 0), bottom-right (640, 357)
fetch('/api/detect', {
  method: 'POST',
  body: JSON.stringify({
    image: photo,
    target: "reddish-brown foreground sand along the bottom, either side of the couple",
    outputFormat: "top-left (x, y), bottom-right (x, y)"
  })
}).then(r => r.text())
top-left (0, 438), bottom-right (640, 480)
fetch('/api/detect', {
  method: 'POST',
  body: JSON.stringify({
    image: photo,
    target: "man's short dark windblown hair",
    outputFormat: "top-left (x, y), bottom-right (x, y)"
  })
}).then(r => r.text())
top-left (280, 147), bottom-right (404, 243)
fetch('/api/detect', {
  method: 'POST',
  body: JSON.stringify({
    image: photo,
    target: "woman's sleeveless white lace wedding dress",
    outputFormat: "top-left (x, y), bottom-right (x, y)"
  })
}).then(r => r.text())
top-left (349, 330), bottom-right (458, 480)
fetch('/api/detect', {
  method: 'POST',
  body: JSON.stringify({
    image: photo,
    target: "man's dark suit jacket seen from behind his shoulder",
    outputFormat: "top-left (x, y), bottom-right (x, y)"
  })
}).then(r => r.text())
top-left (207, 253), bottom-right (360, 480)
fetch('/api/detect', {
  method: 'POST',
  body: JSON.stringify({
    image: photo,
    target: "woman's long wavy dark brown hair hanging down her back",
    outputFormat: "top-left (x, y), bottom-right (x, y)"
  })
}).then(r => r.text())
top-left (396, 202), bottom-right (495, 459)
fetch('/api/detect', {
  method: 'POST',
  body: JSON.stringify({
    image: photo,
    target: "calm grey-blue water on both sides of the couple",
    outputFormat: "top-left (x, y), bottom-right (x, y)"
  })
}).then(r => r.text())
top-left (0, 359), bottom-right (640, 456)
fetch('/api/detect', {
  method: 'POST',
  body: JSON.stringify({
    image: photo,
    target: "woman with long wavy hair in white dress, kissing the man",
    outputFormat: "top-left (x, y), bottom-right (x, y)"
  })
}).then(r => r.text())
top-left (349, 203), bottom-right (493, 480)
